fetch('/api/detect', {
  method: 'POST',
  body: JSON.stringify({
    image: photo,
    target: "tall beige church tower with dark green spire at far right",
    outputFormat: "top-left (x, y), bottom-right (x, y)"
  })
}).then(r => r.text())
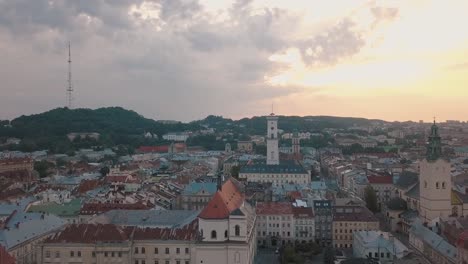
top-left (419, 121), bottom-right (452, 222)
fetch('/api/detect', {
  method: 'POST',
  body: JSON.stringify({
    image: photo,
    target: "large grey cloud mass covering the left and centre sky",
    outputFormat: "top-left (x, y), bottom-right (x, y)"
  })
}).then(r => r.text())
top-left (0, 0), bottom-right (402, 120)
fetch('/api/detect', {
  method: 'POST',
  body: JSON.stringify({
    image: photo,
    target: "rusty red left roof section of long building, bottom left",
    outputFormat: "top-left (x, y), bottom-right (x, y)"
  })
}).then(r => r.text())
top-left (45, 224), bottom-right (130, 243)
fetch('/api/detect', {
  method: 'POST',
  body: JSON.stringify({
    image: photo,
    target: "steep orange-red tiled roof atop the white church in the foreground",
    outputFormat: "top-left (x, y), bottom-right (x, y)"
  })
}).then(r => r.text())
top-left (198, 180), bottom-right (244, 219)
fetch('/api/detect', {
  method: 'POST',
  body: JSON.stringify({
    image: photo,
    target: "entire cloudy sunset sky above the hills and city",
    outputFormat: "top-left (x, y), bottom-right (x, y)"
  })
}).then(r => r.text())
top-left (0, 0), bottom-right (468, 121)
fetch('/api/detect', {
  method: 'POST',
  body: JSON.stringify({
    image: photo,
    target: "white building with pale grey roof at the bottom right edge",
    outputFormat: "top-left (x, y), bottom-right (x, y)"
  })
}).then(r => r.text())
top-left (353, 231), bottom-right (409, 263)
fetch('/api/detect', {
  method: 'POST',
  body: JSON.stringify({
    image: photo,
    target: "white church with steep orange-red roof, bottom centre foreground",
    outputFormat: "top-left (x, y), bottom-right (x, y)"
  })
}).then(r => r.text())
top-left (195, 179), bottom-right (257, 264)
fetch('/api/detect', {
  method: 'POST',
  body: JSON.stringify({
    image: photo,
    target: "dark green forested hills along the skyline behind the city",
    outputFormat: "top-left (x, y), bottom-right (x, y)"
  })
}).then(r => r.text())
top-left (0, 107), bottom-right (383, 153)
